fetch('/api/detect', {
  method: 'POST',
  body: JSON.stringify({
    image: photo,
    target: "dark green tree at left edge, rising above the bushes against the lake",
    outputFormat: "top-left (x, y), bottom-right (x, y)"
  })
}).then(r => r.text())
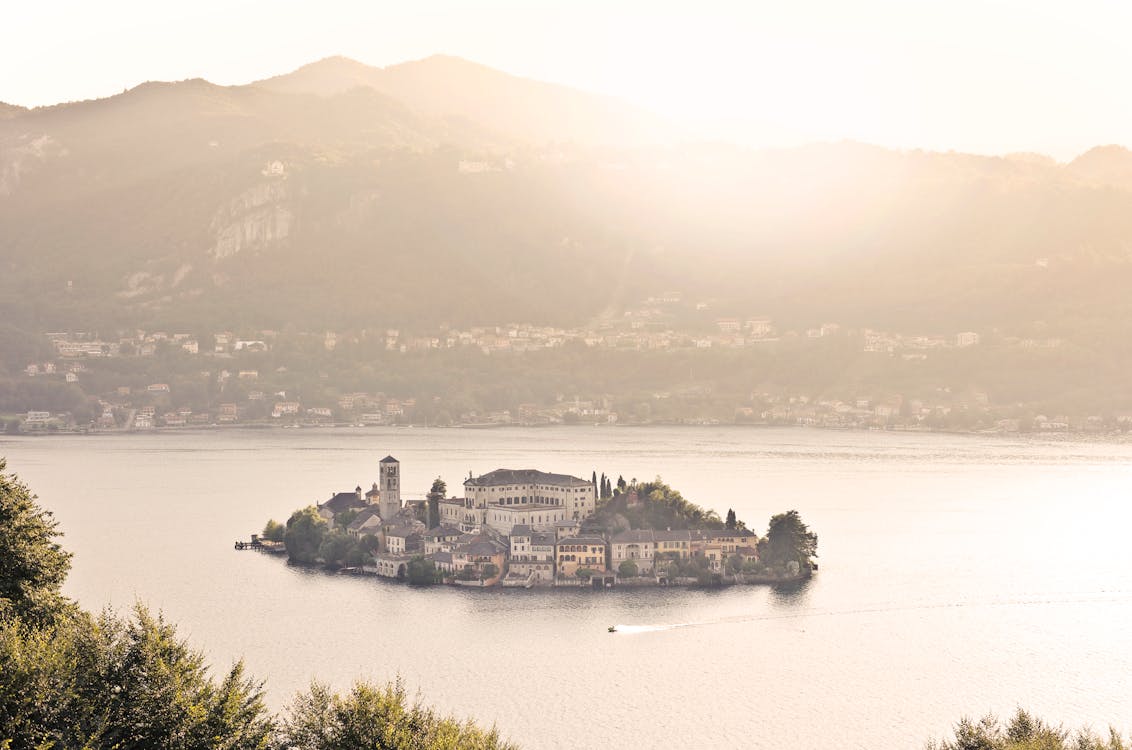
top-left (0, 458), bottom-right (74, 624)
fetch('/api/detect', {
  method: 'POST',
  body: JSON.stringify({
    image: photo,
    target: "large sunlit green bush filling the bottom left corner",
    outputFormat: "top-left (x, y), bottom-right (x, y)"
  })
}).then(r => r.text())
top-left (0, 605), bottom-right (274, 750)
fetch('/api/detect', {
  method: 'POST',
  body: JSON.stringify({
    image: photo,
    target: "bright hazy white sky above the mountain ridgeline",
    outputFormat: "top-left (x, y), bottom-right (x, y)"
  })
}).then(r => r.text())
top-left (0, 0), bottom-right (1132, 158)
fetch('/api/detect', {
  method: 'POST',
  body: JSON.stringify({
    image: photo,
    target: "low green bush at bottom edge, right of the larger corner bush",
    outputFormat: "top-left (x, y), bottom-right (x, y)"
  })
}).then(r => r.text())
top-left (281, 680), bottom-right (513, 750)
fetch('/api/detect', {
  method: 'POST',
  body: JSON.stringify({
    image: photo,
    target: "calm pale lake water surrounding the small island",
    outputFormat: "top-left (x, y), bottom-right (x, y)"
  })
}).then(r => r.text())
top-left (0, 428), bottom-right (1132, 749)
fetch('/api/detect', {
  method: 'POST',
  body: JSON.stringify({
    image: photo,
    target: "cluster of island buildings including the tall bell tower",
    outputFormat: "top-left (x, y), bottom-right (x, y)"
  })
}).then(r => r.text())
top-left (318, 456), bottom-right (758, 587)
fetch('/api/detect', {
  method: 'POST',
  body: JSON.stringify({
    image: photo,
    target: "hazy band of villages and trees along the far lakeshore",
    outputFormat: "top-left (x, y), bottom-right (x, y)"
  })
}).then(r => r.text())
top-left (0, 307), bottom-right (1132, 433)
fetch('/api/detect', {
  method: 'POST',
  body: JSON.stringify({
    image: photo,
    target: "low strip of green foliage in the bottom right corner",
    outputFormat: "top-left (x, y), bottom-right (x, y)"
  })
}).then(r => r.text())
top-left (925, 708), bottom-right (1132, 750)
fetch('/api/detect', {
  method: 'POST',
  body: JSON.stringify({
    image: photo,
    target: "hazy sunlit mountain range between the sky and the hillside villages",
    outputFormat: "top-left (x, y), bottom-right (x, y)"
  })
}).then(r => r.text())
top-left (0, 57), bottom-right (1132, 337)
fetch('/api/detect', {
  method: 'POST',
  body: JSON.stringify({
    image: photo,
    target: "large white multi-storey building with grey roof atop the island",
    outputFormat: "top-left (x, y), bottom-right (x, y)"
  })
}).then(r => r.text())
top-left (440, 468), bottom-right (598, 535)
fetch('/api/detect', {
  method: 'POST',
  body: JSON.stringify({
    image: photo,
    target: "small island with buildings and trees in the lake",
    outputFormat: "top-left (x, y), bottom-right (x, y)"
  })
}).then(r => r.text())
top-left (258, 456), bottom-right (817, 588)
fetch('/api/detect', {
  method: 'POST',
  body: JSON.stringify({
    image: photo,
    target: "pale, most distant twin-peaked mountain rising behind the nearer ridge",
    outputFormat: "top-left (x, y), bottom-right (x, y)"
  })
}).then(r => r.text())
top-left (252, 54), bottom-right (676, 146)
